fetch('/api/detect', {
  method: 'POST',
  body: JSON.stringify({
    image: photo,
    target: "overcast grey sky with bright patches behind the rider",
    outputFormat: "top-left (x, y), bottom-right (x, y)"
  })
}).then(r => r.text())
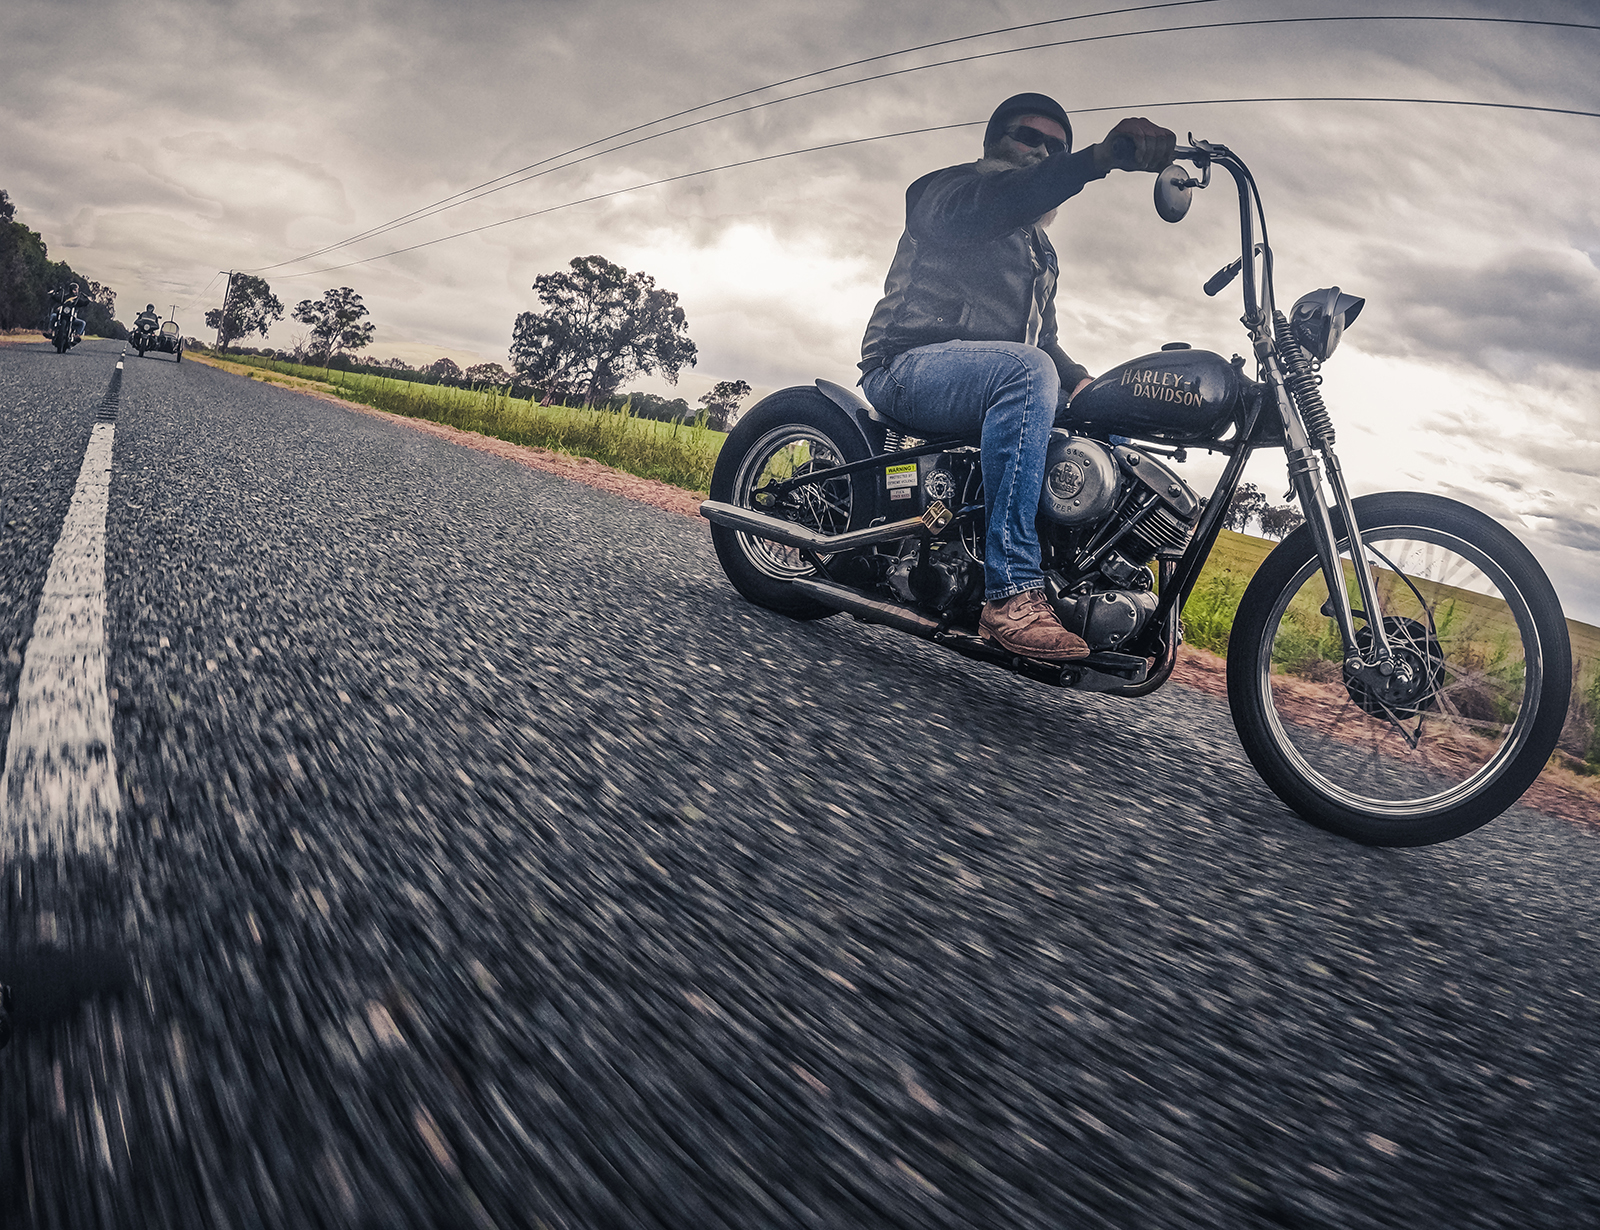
top-left (0, 0), bottom-right (1600, 624)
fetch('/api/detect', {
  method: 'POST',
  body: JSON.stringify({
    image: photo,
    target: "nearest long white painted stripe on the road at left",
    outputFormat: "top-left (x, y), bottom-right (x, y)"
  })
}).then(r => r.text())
top-left (0, 393), bottom-right (122, 859)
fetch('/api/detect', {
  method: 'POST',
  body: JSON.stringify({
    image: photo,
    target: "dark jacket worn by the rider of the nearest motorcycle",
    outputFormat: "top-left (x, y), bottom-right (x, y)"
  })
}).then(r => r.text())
top-left (861, 147), bottom-right (1104, 389)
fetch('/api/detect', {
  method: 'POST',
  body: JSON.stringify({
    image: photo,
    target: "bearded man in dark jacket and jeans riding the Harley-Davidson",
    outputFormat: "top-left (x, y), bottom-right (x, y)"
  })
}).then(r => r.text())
top-left (861, 94), bottom-right (1176, 662)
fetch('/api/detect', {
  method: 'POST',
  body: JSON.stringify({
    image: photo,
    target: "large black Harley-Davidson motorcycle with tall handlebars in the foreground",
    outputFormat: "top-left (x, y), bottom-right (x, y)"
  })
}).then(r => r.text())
top-left (701, 134), bottom-right (1571, 846)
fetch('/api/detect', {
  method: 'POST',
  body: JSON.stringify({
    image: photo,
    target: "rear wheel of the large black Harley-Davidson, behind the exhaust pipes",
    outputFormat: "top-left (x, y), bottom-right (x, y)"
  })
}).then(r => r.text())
top-left (710, 385), bottom-right (872, 619)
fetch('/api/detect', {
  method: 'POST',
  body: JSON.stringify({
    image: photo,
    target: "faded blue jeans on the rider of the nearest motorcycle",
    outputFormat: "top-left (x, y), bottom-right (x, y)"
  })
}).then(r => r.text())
top-left (861, 342), bottom-right (1061, 601)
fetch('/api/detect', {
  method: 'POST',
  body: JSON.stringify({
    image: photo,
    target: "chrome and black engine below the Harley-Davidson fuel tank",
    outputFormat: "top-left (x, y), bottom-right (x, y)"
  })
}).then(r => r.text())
top-left (1040, 429), bottom-right (1200, 649)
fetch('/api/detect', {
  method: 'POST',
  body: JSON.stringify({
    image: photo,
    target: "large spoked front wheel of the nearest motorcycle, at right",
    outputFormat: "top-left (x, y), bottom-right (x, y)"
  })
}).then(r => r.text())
top-left (1227, 493), bottom-right (1571, 846)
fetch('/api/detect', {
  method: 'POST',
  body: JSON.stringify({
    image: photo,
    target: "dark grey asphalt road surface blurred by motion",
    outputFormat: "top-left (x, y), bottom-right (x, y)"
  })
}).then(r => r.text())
top-left (0, 342), bottom-right (1600, 1230)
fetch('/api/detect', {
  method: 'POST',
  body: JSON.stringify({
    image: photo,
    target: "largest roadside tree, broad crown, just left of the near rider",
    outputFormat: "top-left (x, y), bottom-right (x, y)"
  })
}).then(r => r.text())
top-left (510, 256), bottom-right (698, 406)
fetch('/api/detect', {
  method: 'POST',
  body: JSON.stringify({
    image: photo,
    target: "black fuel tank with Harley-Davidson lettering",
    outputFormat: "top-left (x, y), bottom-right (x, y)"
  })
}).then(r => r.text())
top-left (1056, 349), bottom-right (1242, 445)
